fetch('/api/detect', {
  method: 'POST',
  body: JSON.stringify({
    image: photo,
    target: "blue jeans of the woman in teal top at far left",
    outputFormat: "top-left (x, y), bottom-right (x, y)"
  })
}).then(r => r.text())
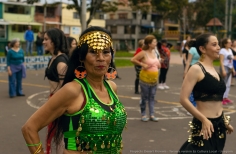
top-left (8, 70), bottom-right (23, 96)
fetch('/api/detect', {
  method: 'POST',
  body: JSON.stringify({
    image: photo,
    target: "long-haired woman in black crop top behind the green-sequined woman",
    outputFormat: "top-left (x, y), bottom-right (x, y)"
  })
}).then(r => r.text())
top-left (43, 28), bottom-right (69, 154)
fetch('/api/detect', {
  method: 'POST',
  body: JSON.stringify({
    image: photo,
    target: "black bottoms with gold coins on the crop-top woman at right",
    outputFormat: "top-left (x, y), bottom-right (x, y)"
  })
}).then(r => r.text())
top-left (178, 114), bottom-right (226, 154)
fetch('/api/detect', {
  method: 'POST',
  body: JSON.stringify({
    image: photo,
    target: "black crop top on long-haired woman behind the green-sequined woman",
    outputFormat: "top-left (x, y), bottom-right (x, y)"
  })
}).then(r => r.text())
top-left (45, 54), bottom-right (68, 82)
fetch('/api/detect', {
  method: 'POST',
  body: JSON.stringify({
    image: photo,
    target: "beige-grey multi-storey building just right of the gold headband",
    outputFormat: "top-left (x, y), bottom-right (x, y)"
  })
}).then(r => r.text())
top-left (106, 1), bottom-right (155, 51)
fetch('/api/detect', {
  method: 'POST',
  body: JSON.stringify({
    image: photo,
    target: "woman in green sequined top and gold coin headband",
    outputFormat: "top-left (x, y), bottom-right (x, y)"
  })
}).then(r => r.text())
top-left (22, 27), bottom-right (127, 154)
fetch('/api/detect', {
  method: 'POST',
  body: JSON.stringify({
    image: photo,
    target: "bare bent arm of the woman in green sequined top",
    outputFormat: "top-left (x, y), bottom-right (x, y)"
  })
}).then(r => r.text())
top-left (22, 82), bottom-right (82, 154)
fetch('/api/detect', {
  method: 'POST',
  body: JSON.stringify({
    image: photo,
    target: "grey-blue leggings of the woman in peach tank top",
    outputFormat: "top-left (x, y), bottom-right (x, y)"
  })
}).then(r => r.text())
top-left (139, 82), bottom-right (157, 116)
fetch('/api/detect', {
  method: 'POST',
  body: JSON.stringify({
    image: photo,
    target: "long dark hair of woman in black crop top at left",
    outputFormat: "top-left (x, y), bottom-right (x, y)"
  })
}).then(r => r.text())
top-left (44, 28), bottom-right (69, 55)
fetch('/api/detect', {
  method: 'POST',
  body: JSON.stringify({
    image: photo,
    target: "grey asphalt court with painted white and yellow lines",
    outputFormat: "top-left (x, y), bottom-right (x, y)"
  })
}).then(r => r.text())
top-left (0, 54), bottom-right (236, 154)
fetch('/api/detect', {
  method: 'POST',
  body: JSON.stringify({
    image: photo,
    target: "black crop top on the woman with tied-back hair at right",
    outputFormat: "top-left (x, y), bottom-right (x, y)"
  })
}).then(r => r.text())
top-left (193, 63), bottom-right (226, 102)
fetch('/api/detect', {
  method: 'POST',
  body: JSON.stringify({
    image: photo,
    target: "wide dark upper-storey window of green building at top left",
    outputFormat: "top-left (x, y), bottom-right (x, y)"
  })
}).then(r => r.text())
top-left (5, 4), bottom-right (30, 14)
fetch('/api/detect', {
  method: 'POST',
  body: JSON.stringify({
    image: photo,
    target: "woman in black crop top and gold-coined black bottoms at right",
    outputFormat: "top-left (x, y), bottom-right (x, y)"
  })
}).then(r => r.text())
top-left (179, 34), bottom-right (233, 154)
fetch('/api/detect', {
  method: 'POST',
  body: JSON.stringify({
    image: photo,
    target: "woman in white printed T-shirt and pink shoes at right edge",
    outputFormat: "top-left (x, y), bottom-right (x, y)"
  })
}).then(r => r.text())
top-left (219, 38), bottom-right (235, 105)
